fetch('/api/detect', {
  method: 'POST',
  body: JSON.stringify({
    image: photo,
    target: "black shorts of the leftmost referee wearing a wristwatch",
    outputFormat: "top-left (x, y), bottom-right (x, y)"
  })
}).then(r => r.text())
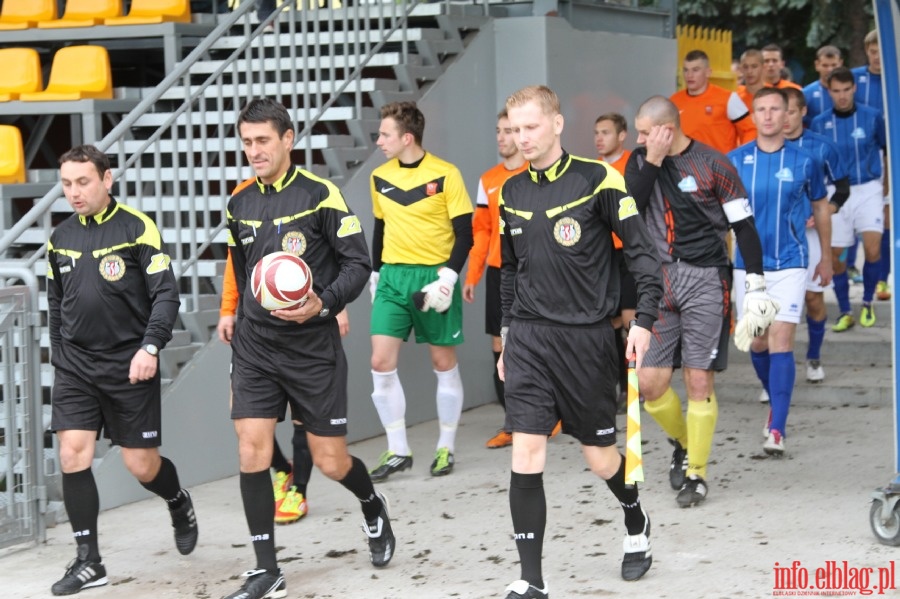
top-left (50, 356), bottom-right (162, 448)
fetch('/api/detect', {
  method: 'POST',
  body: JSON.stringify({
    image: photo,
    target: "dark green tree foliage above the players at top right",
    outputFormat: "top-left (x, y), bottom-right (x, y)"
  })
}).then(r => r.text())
top-left (678, 0), bottom-right (874, 83)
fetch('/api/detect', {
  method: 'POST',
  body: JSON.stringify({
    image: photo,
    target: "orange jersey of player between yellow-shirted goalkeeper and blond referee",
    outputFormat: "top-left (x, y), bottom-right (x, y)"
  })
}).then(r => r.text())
top-left (466, 162), bottom-right (528, 285)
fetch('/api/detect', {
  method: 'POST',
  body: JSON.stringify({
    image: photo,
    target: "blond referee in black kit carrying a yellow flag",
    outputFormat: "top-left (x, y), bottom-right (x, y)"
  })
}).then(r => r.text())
top-left (498, 86), bottom-right (662, 599)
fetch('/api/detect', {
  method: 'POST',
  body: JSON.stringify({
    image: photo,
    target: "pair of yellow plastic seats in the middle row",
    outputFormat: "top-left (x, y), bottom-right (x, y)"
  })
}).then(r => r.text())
top-left (0, 46), bottom-right (113, 102)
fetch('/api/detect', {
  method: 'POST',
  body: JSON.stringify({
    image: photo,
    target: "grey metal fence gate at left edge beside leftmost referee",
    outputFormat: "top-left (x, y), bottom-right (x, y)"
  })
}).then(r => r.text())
top-left (0, 265), bottom-right (45, 549)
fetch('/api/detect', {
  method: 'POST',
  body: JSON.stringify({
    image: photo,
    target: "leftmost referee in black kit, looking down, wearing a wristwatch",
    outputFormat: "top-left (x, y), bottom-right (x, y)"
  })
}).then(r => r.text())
top-left (47, 146), bottom-right (197, 595)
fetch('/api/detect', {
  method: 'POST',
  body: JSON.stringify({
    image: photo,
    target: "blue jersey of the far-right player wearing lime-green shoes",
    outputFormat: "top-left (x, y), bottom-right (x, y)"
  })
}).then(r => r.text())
top-left (810, 104), bottom-right (887, 185)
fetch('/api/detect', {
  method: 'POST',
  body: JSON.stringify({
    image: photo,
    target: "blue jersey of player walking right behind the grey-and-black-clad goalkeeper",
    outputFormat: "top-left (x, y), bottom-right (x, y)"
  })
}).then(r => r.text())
top-left (728, 141), bottom-right (827, 271)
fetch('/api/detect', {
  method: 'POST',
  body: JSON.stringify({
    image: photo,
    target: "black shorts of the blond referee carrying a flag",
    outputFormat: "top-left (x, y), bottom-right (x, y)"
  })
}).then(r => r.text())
top-left (503, 320), bottom-right (618, 447)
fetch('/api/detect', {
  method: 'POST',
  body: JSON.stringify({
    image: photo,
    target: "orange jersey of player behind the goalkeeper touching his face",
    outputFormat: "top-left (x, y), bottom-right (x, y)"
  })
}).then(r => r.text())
top-left (670, 83), bottom-right (756, 154)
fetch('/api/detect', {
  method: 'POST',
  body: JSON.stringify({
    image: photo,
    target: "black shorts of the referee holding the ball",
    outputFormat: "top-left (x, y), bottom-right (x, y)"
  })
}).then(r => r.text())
top-left (231, 319), bottom-right (347, 437)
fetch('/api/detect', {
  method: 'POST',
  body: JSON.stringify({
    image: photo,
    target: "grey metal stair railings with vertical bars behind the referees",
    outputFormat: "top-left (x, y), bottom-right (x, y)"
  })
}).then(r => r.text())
top-left (0, 0), bottom-right (419, 310)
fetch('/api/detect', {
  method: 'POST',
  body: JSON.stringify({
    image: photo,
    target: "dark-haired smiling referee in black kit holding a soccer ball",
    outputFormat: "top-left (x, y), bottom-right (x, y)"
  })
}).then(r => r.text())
top-left (226, 98), bottom-right (395, 599)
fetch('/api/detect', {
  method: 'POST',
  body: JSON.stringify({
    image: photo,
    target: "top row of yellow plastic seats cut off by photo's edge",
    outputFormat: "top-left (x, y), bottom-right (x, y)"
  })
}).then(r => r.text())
top-left (0, 0), bottom-right (191, 31)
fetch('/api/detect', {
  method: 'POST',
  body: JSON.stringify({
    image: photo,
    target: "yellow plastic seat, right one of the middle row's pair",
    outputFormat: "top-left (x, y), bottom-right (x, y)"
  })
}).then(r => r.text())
top-left (19, 46), bottom-right (113, 102)
